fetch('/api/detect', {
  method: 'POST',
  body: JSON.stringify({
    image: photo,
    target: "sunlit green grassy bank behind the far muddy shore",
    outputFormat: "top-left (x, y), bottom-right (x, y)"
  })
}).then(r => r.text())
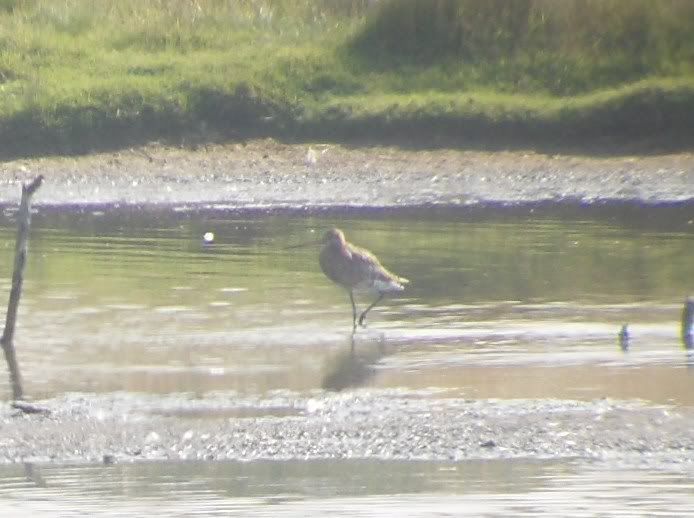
top-left (0, 0), bottom-right (694, 156)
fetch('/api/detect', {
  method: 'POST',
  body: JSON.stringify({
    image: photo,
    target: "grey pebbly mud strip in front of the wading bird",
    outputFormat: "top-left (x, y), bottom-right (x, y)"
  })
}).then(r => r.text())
top-left (0, 391), bottom-right (694, 466)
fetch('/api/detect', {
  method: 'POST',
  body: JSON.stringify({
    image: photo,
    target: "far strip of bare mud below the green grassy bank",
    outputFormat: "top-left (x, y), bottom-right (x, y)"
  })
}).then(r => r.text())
top-left (0, 140), bottom-right (694, 208)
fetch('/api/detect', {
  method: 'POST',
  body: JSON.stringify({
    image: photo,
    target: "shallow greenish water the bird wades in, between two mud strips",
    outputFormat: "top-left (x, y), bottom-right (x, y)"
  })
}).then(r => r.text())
top-left (0, 209), bottom-right (694, 405)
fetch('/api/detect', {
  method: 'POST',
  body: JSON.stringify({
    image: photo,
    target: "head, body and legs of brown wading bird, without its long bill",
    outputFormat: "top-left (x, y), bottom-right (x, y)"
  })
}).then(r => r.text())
top-left (318, 228), bottom-right (410, 329)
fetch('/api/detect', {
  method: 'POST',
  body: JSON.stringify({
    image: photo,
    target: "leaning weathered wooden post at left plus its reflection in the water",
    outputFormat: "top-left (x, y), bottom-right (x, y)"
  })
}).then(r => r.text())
top-left (0, 176), bottom-right (43, 401)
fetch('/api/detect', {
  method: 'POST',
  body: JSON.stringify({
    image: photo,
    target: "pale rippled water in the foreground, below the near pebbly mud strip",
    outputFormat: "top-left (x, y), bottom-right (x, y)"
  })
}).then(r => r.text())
top-left (0, 460), bottom-right (694, 517)
